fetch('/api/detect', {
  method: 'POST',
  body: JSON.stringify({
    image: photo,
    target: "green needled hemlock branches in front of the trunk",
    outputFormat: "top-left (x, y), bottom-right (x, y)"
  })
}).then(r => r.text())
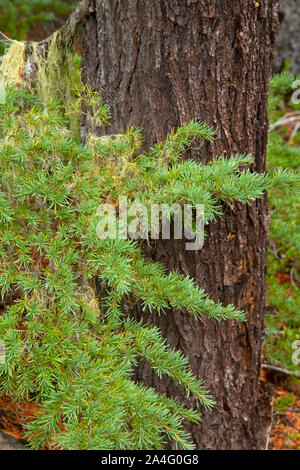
top-left (0, 51), bottom-right (298, 449)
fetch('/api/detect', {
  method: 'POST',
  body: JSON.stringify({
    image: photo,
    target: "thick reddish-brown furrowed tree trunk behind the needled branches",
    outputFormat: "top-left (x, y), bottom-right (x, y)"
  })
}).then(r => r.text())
top-left (83, 0), bottom-right (277, 449)
